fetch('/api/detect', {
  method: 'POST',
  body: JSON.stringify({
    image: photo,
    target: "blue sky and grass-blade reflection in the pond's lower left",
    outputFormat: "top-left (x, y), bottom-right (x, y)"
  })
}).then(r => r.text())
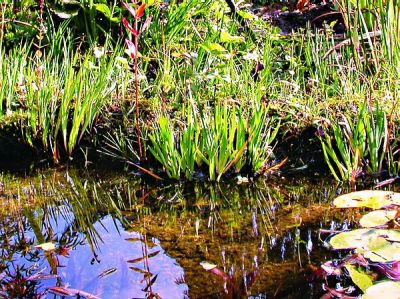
top-left (0, 171), bottom-right (188, 298)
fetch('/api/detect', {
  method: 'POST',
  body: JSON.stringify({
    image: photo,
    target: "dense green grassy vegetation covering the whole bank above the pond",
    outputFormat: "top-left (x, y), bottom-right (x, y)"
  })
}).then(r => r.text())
top-left (0, 0), bottom-right (400, 182)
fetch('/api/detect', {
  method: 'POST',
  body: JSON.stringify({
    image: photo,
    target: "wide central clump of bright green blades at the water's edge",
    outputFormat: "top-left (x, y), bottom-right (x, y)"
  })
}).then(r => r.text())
top-left (149, 104), bottom-right (279, 181)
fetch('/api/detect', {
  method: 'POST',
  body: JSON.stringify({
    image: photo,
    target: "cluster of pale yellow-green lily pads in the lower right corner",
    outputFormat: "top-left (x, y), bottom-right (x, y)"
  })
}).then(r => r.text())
top-left (322, 190), bottom-right (400, 299)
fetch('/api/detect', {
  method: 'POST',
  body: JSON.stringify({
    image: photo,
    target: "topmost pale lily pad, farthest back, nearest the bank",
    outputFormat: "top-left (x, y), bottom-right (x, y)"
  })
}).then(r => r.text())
top-left (333, 190), bottom-right (400, 210)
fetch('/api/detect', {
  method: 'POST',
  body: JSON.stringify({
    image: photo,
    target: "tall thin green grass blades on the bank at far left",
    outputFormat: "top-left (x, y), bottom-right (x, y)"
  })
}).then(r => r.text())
top-left (0, 30), bottom-right (122, 159)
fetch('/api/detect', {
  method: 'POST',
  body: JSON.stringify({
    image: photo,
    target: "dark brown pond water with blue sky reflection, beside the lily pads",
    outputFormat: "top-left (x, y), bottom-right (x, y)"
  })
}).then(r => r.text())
top-left (0, 169), bottom-right (362, 298)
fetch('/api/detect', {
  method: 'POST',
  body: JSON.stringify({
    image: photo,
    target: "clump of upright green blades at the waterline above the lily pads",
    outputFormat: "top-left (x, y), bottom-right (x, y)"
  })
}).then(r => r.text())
top-left (319, 104), bottom-right (393, 182)
